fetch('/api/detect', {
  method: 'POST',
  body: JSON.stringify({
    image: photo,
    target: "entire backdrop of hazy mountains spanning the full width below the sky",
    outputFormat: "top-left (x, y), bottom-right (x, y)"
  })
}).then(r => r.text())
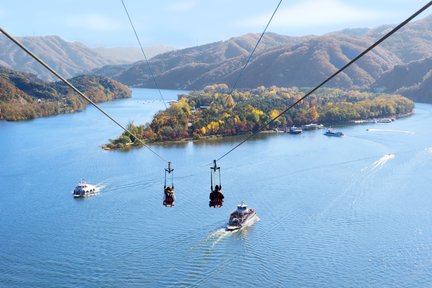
top-left (0, 16), bottom-right (432, 101)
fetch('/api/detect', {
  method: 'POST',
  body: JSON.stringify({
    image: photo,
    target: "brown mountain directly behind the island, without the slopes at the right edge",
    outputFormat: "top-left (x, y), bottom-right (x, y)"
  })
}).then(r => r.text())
top-left (104, 33), bottom-right (401, 89)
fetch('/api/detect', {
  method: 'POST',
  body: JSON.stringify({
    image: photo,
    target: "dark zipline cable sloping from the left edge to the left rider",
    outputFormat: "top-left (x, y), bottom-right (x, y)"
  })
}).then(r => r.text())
top-left (0, 27), bottom-right (168, 162)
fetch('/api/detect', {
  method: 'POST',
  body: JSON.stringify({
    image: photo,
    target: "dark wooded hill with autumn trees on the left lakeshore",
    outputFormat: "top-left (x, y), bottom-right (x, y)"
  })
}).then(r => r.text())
top-left (0, 66), bottom-right (131, 121)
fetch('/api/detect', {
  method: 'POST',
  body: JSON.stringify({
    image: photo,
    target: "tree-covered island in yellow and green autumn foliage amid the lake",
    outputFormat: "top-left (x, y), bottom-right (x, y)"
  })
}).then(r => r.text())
top-left (103, 84), bottom-right (414, 150)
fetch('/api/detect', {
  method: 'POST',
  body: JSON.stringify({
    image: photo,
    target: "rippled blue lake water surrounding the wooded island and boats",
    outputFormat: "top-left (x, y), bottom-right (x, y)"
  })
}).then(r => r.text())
top-left (0, 89), bottom-right (432, 287)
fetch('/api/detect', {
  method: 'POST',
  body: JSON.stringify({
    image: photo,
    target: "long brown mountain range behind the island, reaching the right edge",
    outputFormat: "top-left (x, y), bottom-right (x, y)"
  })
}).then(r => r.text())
top-left (94, 16), bottom-right (432, 103)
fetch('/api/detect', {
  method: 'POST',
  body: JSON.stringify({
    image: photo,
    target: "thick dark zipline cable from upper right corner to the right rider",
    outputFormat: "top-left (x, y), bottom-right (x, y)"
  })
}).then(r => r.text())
top-left (216, 1), bottom-right (432, 161)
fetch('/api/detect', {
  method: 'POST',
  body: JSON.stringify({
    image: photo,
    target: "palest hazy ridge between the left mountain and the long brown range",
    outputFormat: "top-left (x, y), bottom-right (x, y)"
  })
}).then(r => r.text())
top-left (93, 45), bottom-right (176, 64)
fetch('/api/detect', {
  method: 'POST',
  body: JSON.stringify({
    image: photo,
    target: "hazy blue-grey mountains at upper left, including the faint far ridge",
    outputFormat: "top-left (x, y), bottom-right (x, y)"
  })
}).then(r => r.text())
top-left (0, 33), bottom-right (174, 81)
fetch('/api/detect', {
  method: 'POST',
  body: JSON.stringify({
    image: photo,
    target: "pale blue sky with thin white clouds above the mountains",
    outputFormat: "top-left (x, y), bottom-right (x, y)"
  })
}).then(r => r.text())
top-left (0, 0), bottom-right (432, 48)
